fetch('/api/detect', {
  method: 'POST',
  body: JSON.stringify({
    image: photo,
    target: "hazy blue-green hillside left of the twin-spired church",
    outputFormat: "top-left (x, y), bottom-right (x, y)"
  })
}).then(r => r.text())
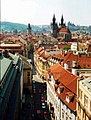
top-left (1, 22), bottom-right (50, 33)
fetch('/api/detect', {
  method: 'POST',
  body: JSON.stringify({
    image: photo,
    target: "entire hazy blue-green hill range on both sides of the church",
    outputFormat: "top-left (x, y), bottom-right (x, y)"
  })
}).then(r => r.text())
top-left (0, 22), bottom-right (91, 34)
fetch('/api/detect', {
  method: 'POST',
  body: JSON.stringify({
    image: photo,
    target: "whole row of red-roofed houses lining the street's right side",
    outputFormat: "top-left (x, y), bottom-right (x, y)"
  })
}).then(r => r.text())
top-left (34, 47), bottom-right (91, 120)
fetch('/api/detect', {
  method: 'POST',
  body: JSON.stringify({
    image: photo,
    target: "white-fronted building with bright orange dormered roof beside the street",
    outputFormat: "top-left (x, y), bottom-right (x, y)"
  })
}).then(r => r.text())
top-left (47, 63), bottom-right (77, 120)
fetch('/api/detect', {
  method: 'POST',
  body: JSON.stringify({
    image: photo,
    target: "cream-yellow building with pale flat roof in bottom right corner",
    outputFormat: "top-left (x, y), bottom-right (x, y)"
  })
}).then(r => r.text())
top-left (77, 77), bottom-right (91, 120)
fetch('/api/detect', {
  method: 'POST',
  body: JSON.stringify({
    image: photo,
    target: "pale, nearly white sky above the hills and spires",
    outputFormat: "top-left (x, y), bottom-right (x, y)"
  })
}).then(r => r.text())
top-left (1, 0), bottom-right (91, 25)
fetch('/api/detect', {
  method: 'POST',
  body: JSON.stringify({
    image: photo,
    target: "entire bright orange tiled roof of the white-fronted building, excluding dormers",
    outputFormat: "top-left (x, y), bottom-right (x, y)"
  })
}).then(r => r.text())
top-left (49, 63), bottom-right (78, 110)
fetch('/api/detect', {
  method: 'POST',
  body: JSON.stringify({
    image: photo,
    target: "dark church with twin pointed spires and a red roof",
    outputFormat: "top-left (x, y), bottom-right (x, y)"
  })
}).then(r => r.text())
top-left (51, 14), bottom-right (72, 42)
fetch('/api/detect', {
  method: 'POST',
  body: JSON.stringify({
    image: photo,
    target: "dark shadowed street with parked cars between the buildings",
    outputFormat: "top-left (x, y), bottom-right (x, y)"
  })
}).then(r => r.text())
top-left (21, 52), bottom-right (51, 120)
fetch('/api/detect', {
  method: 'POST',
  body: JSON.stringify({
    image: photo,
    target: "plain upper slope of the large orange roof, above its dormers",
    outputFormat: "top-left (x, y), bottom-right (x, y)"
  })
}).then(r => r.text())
top-left (50, 63), bottom-right (77, 94)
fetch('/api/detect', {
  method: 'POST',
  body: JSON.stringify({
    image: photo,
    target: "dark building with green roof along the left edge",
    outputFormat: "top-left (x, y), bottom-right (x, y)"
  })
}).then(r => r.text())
top-left (0, 51), bottom-right (23, 120)
